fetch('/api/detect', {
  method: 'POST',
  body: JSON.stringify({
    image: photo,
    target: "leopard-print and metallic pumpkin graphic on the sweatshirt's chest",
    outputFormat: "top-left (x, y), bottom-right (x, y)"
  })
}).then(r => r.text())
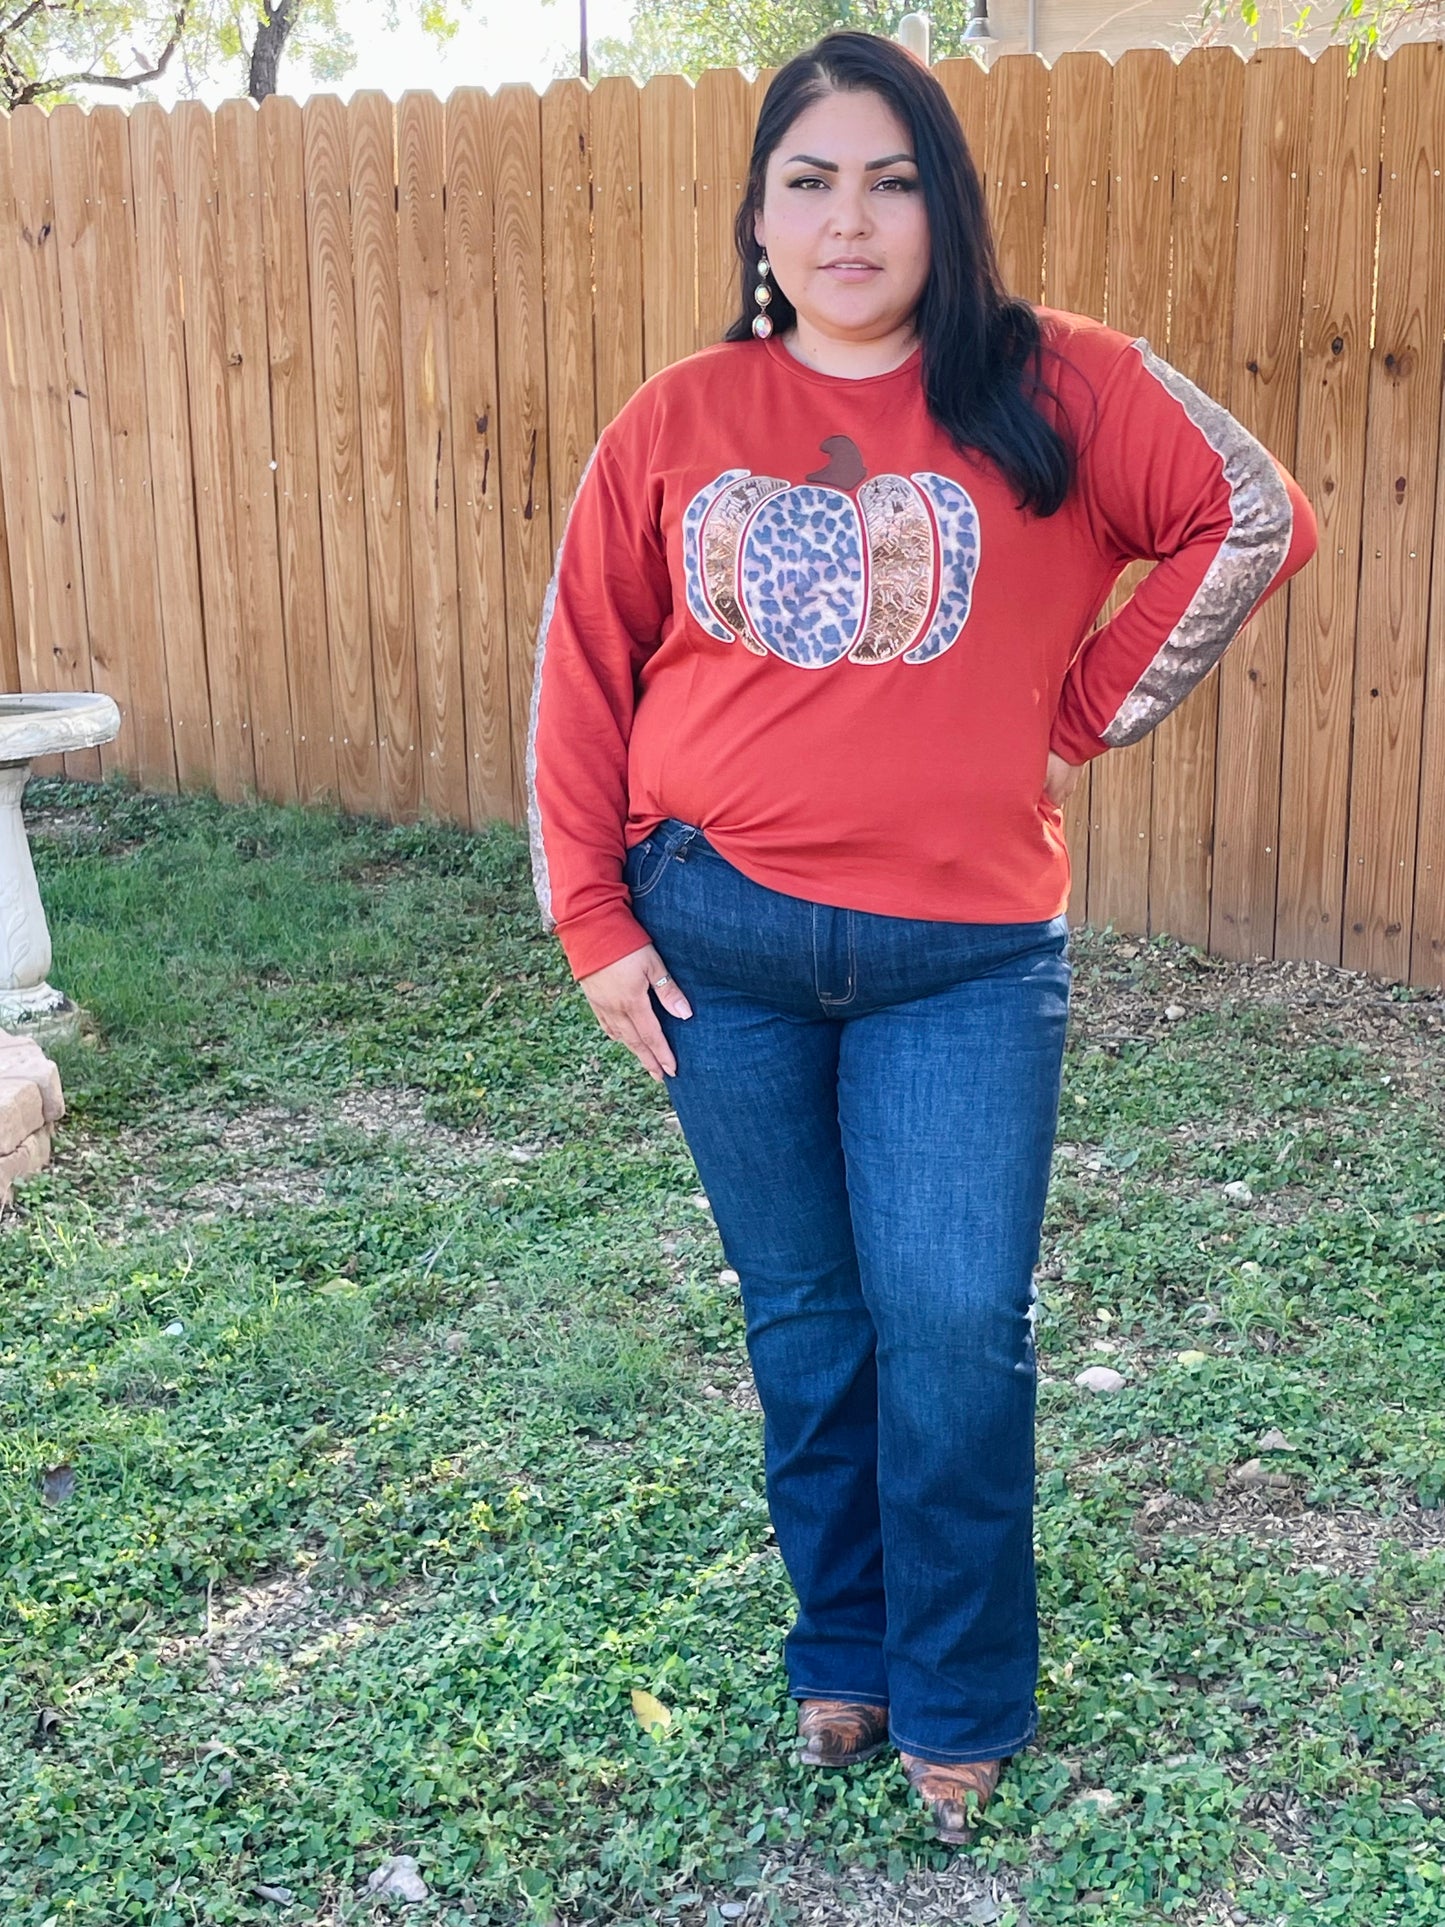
top-left (682, 436), bottom-right (979, 669)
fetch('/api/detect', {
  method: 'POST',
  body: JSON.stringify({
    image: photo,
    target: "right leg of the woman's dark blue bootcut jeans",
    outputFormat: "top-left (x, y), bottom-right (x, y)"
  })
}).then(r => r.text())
top-left (838, 927), bottom-right (1069, 1761)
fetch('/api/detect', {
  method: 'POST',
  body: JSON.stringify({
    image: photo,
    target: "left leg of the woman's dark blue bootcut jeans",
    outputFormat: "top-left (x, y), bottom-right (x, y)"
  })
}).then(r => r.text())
top-left (672, 1009), bottom-right (888, 1705)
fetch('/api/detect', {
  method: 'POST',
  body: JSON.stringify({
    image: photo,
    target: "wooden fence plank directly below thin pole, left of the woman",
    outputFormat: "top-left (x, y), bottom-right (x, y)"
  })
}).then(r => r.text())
top-left (541, 81), bottom-right (607, 540)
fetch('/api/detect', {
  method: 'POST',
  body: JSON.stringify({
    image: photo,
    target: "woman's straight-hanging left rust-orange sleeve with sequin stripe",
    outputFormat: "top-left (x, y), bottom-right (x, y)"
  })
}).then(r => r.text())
top-left (526, 431), bottom-right (672, 977)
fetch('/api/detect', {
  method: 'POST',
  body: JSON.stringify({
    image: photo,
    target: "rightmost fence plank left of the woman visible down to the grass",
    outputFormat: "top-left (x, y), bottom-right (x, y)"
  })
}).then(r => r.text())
top-left (447, 87), bottom-right (516, 827)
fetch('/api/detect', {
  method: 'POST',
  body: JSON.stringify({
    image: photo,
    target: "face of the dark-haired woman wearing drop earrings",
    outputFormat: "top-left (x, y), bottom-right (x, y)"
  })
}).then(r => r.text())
top-left (753, 92), bottom-right (929, 341)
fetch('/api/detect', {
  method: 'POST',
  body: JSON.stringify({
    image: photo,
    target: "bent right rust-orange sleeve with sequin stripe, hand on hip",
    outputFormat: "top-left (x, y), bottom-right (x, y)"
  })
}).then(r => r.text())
top-left (1050, 337), bottom-right (1318, 763)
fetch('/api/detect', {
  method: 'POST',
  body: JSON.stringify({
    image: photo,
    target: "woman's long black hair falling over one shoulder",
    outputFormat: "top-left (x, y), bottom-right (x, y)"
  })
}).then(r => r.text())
top-left (724, 29), bottom-right (1075, 515)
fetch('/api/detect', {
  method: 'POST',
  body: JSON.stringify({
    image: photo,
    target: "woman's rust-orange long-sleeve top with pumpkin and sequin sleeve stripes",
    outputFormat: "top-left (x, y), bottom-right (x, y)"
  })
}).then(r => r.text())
top-left (528, 308), bottom-right (1316, 977)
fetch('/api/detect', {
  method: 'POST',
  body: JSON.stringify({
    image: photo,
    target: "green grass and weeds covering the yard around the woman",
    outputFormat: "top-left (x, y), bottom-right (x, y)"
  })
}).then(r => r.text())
top-left (0, 784), bottom-right (1445, 1927)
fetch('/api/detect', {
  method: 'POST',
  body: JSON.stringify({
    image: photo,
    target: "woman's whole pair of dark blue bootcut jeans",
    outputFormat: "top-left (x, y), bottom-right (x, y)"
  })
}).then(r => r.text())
top-left (624, 819), bottom-right (1071, 1761)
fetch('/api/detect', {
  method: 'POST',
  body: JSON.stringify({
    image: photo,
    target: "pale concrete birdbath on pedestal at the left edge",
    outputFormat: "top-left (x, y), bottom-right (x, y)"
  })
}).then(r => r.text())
top-left (0, 692), bottom-right (119, 1031)
